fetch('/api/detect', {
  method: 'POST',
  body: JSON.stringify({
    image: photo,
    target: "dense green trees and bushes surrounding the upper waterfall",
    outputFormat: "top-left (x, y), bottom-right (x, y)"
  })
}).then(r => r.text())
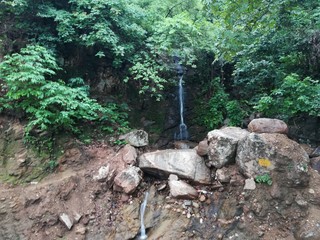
top-left (0, 0), bottom-right (320, 138)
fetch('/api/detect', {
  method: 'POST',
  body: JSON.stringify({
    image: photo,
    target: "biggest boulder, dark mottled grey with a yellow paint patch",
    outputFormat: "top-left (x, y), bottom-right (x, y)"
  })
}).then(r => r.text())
top-left (236, 133), bottom-right (310, 187)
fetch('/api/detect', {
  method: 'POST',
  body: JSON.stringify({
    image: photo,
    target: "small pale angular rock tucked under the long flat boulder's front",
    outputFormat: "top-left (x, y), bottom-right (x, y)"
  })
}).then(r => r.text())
top-left (169, 180), bottom-right (198, 199)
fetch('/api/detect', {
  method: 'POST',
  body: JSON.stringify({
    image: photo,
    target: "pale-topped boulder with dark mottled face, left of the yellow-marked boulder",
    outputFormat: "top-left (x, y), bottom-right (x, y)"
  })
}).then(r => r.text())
top-left (207, 127), bottom-right (249, 168)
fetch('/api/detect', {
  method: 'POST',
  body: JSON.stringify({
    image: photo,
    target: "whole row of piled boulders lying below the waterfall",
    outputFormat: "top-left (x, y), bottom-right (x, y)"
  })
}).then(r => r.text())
top-left (94, 118), bottom-right (316, 199)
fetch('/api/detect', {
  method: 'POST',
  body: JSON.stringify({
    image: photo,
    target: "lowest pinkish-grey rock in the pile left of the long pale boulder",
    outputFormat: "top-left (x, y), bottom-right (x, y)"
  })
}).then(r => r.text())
top-left (113, 166), bottom-right (142, 194)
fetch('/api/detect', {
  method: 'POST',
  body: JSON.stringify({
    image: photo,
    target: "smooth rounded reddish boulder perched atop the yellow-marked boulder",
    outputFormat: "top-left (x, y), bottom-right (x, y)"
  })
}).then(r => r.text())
top-left (248, 118), bottom-right (288, 134)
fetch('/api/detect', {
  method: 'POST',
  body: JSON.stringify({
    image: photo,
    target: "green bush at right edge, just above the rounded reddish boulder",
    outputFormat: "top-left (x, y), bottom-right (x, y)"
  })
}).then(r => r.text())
top-left (255, 74), bottom-right (320, 119)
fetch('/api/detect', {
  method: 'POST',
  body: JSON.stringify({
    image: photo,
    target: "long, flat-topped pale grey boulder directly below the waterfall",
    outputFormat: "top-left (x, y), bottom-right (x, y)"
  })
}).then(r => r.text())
top-left (138, 149), bottom-right (211, 184)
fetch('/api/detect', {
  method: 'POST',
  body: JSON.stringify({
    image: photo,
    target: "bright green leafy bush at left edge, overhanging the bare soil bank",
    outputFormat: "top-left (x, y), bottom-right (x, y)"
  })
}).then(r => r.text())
top-left (0, 45), bottom-right (126, 136)
